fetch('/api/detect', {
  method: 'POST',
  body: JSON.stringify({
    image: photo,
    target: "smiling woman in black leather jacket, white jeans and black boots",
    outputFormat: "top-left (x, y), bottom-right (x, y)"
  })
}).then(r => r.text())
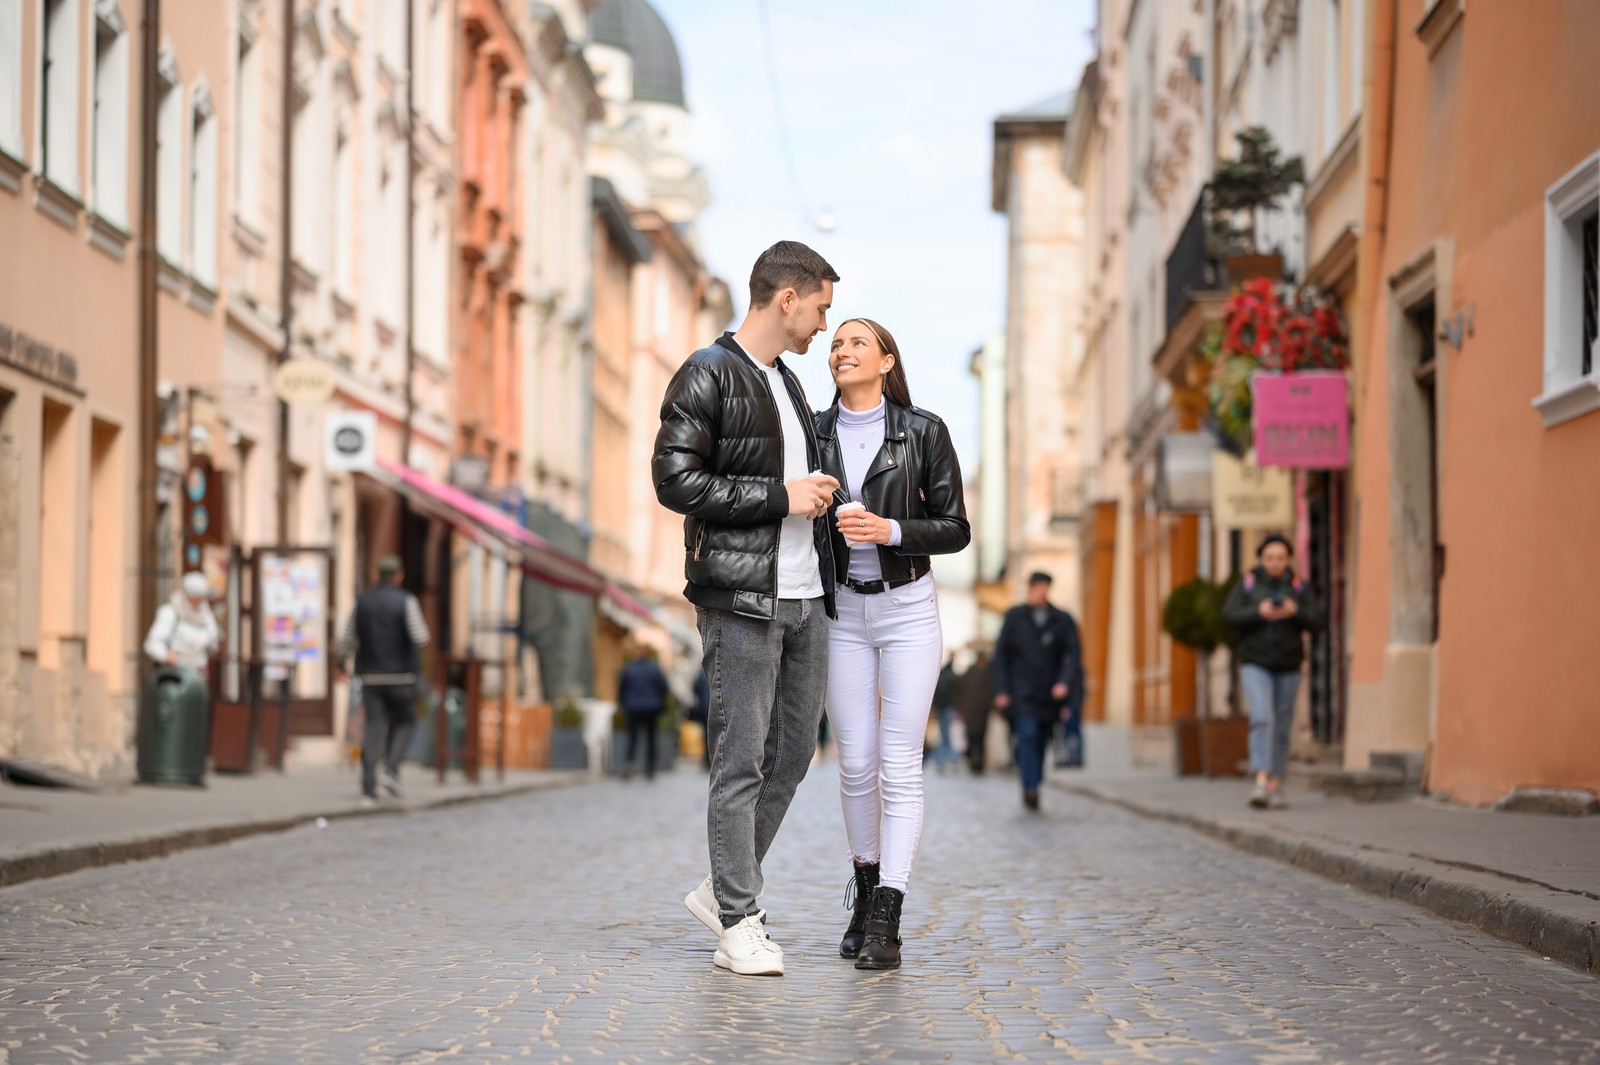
top-left (816, 311), bottom-right (971, 969)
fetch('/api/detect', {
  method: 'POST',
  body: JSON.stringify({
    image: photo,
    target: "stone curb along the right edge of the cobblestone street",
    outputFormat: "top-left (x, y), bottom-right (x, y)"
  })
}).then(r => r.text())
top-left (1054, 782), bottom-right (1600, 974)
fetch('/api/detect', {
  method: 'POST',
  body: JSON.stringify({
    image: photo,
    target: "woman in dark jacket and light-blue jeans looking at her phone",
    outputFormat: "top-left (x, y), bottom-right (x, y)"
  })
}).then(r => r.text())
top-left (1222, 536), bottom-right (1323, 809)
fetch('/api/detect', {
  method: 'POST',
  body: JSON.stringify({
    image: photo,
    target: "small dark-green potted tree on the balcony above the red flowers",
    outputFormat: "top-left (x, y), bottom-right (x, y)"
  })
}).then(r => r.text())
top-left (1208, 126), bottom-right (1306, 285)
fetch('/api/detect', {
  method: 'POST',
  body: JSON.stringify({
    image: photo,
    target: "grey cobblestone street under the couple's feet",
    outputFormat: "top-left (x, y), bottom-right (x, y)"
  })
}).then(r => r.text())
top-left (0, 766), bottom-right (1600, 1065)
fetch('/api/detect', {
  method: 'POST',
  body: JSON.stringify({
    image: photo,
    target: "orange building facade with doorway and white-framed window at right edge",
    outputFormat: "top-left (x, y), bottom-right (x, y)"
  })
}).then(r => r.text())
top-left (1346, 0), bottom-right (1600, 803)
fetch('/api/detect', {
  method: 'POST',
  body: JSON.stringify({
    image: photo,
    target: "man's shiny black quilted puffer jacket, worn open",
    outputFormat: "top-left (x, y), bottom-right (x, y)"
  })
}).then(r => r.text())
top-left (650, 333), bottom-right (835, 619)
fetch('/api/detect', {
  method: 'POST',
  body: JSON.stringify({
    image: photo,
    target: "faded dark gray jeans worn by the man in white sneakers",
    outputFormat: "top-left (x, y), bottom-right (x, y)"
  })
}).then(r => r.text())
top-left (698, 598), bottom-right (827, 927)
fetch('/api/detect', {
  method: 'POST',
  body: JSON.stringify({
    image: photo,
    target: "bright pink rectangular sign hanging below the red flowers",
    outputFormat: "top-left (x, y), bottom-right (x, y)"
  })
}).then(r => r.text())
top-left (1250, 371), bottom-right (1350, 470)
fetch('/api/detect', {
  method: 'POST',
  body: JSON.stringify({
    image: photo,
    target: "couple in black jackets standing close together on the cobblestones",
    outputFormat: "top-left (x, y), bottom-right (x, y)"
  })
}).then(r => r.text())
top-left (651, 241), bottom-right (971, 975)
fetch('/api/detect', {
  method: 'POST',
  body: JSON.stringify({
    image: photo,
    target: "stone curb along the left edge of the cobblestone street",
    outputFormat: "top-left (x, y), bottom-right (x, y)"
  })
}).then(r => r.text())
top-left (0, 774), bottom-right (587, 889)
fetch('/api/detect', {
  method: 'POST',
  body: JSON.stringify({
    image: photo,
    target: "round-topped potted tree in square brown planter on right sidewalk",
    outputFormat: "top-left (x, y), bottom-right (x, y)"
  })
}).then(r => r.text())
top-left (1162, 574), bottom-right (1250, 777)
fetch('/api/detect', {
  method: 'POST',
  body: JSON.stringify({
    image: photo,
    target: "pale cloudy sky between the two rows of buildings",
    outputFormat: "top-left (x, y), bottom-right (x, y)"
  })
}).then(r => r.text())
top-left (653, 0), bottom-right (1094, 463)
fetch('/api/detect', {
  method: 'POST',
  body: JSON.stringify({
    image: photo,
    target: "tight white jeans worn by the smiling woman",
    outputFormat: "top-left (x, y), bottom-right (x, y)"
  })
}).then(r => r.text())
top-left (827, 574), bottom-right (944, 891)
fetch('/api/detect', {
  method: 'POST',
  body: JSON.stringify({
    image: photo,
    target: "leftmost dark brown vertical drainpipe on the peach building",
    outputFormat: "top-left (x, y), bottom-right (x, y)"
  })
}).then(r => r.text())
top-left (138, 0), bottom-right (162, 633)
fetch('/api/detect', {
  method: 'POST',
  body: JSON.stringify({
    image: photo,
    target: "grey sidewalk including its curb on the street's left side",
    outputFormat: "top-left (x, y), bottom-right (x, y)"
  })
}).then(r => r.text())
top-left (0, 766), bottom-right (586, 888)
